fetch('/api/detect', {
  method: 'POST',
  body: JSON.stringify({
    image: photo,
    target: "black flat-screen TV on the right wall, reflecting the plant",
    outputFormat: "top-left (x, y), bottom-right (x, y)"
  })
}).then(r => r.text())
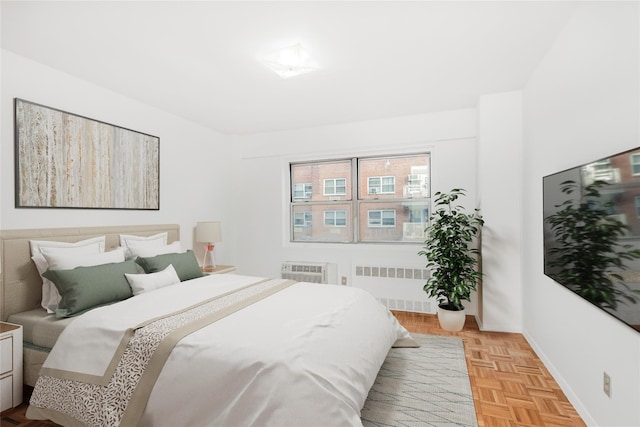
top-left (543, 147), bottom-right (640, 331)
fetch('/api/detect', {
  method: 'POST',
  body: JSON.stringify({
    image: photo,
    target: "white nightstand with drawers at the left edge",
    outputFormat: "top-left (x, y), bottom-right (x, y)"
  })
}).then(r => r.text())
top-left (0, 322), bottom-right (22, 411)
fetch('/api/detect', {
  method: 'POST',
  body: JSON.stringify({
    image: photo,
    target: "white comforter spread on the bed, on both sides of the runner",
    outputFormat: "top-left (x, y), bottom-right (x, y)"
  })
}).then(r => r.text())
top-left (28, 275), bottom-right (410, 427)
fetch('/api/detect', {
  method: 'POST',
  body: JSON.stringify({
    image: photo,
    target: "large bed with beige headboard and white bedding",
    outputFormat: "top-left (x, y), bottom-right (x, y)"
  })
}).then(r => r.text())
top-left (1, 225), bottom-right (415, 427)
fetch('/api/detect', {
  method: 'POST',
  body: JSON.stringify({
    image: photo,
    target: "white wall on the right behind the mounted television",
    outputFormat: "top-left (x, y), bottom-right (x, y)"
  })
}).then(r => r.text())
top-left (523, 2), bottom-right (640, 426)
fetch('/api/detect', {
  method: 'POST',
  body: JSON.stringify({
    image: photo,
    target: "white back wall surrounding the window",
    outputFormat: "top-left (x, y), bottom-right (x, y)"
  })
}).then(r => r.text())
top-left (233, 109), bottom-right (477, 314)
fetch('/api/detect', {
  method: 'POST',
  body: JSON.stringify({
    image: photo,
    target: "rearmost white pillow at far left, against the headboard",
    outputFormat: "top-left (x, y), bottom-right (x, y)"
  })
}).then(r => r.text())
top-left (29, 236), bottom-right (106, 313)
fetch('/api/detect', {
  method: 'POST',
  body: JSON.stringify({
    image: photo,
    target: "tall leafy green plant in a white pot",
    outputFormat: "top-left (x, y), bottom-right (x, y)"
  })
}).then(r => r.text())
top-left (418, 188), bottom-right (484, 331)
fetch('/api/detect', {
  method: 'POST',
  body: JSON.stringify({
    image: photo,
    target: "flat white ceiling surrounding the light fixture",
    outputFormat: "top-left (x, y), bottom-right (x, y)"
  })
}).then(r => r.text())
top-left (1, 0), bottom-right (580, 134)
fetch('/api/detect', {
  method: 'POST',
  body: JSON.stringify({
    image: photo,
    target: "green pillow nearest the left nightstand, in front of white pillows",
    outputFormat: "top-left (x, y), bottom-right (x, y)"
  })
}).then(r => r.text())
top-left (44, 260), bottom-right (137, 318)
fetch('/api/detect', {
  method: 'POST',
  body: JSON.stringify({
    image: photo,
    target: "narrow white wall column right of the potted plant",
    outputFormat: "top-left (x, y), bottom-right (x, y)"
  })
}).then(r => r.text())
top-left (478, 91), bottom-right (522, 332)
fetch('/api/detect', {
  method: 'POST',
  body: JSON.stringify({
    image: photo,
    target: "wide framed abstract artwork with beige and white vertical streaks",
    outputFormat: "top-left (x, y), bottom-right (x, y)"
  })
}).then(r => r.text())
top-left (14, 98), bottom-right (160, 210)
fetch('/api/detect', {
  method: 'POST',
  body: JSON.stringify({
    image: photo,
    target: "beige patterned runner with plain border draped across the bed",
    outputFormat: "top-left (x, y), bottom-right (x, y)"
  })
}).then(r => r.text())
top-left (27, 279), bottom-right (296, 427)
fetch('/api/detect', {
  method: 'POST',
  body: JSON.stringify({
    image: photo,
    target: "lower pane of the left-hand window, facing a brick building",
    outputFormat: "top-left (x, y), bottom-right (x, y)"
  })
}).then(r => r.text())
top-left (292, 203), bottom-right (353, 243)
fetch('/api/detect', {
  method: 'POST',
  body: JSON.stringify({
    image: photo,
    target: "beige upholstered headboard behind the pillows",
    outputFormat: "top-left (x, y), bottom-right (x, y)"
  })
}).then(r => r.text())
top-left (0, 224), bottom-right (180, 320)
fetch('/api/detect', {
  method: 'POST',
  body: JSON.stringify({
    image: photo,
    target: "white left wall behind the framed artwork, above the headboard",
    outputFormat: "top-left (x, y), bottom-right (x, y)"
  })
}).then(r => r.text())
top-left (0, 50), bottom-right (232, 263)
